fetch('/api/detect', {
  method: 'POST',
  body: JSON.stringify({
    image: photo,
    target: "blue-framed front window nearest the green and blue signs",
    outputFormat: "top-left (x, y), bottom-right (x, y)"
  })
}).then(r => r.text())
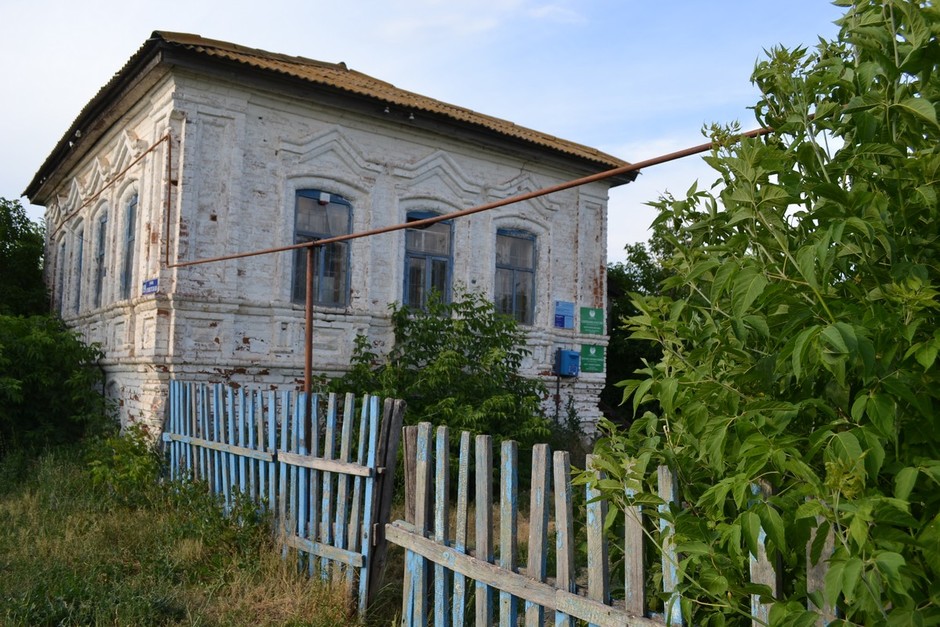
top-left (494, 229), bottom-right (535, 324)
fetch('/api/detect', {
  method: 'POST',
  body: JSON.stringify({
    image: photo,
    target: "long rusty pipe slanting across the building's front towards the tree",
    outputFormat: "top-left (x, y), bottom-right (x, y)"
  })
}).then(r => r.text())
top-left (168, 127), bottom-right (773, 268)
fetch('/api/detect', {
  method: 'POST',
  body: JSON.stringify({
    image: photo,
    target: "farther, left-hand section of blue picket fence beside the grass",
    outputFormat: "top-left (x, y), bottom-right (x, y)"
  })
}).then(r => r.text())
top-left (163, 381), bottom-right (404, 613)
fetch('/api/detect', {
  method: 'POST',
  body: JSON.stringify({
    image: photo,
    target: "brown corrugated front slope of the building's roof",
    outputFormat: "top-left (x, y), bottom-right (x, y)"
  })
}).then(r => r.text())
top-left (153, 31), bottom-right (627, 169)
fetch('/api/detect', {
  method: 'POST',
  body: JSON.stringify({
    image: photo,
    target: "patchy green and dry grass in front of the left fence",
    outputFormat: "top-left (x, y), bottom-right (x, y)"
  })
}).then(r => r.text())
top-left (0, 446), bottom-right (358, 626)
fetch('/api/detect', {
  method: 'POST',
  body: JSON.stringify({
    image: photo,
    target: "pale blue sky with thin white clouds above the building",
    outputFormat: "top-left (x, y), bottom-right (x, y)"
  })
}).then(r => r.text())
top-left (0, 0), bottom-right (842, 262)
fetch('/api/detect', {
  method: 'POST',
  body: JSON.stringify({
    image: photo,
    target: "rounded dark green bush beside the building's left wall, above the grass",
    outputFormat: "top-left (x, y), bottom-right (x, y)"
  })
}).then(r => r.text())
top-left (0, 316), bottom-right (112, 454)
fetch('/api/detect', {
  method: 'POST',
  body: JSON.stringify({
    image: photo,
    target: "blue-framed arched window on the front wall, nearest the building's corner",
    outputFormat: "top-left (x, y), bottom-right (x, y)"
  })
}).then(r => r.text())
top-left (291, 189), bottom-right (352, 307)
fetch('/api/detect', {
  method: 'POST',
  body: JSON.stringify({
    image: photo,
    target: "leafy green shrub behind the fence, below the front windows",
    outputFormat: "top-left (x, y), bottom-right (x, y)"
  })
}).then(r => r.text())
top-left (333, 292), bottom-right (550, 444)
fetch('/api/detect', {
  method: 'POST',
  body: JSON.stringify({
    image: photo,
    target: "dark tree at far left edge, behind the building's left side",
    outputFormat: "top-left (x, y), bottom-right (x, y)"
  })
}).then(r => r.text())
top-left (0, 198), bottom-right (48, 316)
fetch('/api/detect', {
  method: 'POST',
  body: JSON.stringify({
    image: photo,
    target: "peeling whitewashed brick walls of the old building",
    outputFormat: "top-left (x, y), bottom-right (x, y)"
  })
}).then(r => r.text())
top-left (38, 63), bottom-right (608, 436)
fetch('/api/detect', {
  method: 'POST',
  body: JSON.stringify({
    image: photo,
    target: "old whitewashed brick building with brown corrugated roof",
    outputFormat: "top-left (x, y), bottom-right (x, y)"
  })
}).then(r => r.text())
top-left (26, 32), bottom-right (630, 432)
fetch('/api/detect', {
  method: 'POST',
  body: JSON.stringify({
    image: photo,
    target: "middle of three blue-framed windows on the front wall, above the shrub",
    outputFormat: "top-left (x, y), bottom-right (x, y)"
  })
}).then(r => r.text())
top-left (404, 211), bottom-right (453, 309)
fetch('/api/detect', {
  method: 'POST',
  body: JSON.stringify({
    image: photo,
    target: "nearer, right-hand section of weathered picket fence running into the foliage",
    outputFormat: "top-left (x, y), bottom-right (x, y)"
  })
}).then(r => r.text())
top-left (386, 424), bottom-right (833, 627)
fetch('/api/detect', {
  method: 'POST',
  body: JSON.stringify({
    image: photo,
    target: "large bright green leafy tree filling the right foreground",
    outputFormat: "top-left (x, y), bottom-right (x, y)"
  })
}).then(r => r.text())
top-left (601, 0), bottom-right (940, 625)
